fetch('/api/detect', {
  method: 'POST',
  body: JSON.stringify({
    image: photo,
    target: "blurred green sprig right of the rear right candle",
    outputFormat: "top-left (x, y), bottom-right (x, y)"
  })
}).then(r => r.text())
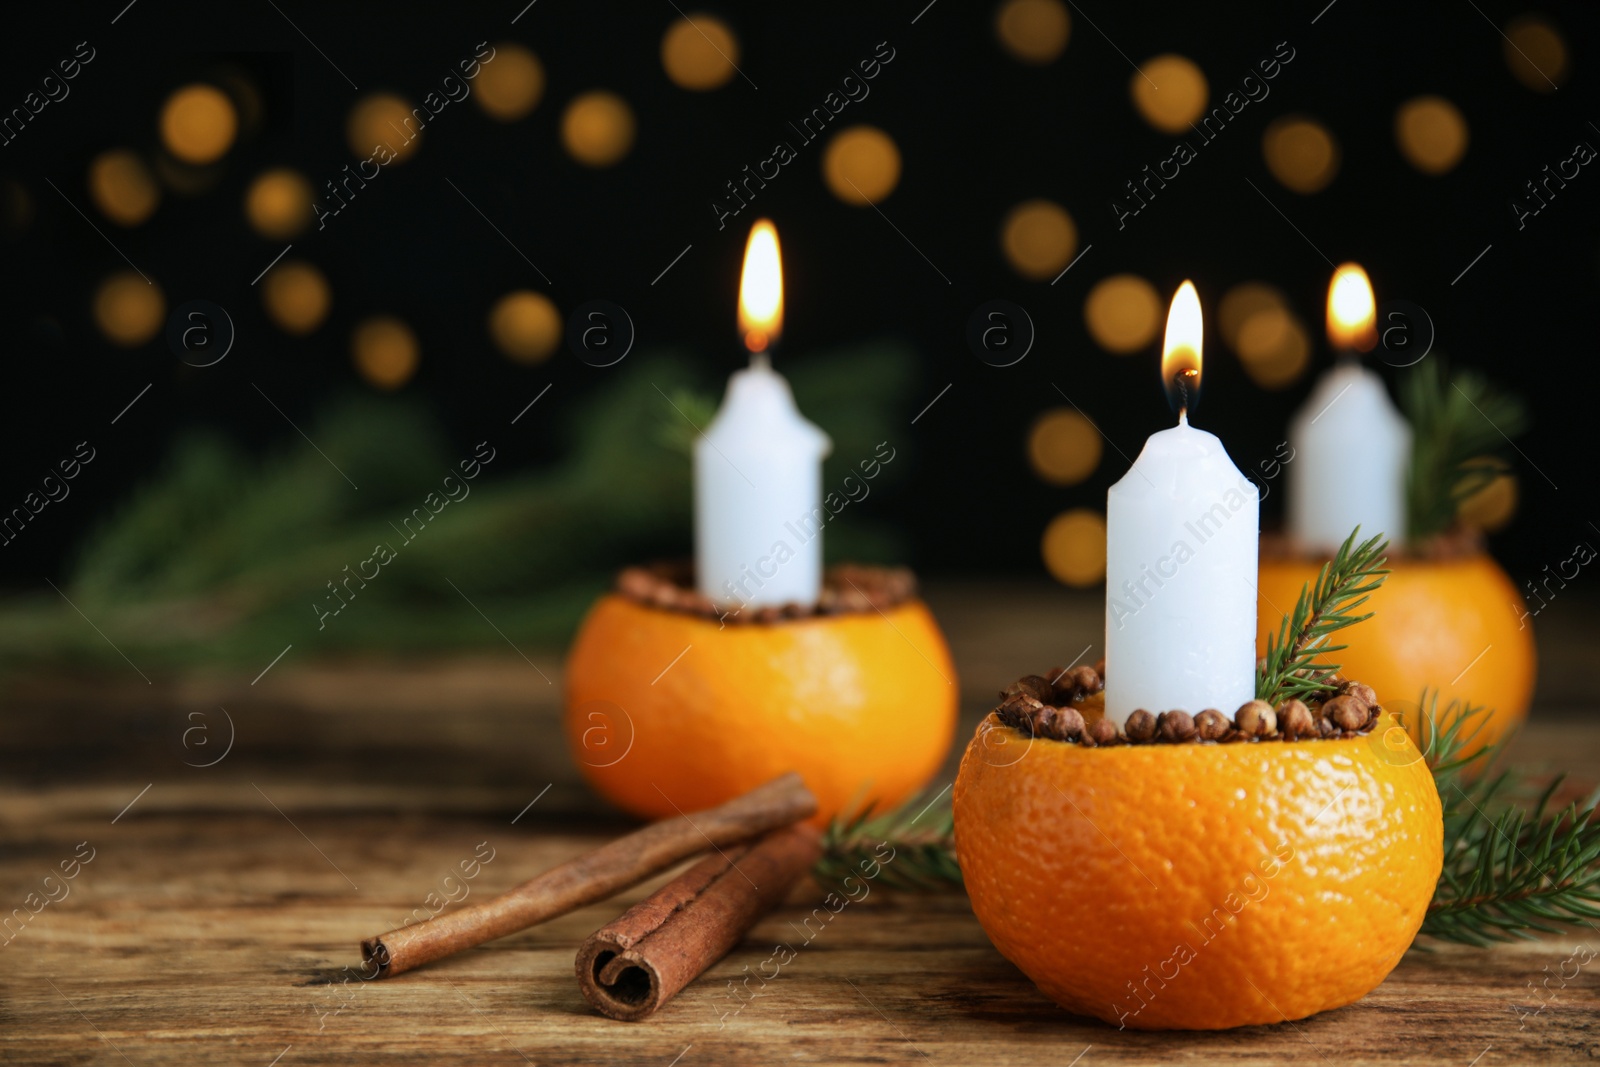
top-left (1400, 358), bottom-right (1528, 545)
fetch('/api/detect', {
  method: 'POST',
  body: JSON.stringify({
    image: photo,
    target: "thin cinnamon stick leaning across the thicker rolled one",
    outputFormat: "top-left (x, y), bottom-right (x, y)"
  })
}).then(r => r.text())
top-left (362, 774), bottom-right (816, 977)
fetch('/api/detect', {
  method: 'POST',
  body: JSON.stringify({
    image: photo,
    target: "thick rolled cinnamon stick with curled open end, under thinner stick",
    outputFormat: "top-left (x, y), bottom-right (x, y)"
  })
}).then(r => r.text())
top-left (576, 825), bottom-right (822, 1022)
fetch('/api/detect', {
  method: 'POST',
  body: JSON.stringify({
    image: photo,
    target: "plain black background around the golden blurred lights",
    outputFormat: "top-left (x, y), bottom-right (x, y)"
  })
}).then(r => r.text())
top-left (0, 0), bottom-right (1600, 585)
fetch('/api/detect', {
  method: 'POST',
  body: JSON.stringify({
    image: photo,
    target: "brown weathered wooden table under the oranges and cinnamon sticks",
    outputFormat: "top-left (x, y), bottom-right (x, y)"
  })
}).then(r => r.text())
top-left (0, 584), bottom-right (1600, 1067)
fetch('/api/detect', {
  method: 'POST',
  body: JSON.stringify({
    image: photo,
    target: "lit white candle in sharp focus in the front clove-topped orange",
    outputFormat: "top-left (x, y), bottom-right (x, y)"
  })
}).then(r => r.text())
top-left (1106, 282), bottom-right (1261, 726)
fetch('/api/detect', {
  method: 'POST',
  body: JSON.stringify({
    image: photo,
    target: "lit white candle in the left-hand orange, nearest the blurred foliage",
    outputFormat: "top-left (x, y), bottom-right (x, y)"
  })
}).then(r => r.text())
top-left (694, 219), bottom-right (832, 609)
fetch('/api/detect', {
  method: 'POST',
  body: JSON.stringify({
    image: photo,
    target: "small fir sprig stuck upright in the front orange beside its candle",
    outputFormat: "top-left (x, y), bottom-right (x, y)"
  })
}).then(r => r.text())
top-left (1256, 526), bottom-right (1389, 707)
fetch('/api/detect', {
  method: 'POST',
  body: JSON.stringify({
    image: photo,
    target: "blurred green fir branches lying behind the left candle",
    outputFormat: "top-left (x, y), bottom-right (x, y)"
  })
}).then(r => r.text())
top-left (0, 344), bottom-right (914, 670)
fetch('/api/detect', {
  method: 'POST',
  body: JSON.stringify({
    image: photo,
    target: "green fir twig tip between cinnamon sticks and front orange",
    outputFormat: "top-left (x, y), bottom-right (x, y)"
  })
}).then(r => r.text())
top-left (811, 793), bottom-right (962, 893)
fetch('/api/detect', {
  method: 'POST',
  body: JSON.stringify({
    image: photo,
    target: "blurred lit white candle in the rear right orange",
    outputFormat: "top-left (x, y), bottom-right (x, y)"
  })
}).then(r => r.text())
top-left (1288, 262), bottom-right (1411, 555)
